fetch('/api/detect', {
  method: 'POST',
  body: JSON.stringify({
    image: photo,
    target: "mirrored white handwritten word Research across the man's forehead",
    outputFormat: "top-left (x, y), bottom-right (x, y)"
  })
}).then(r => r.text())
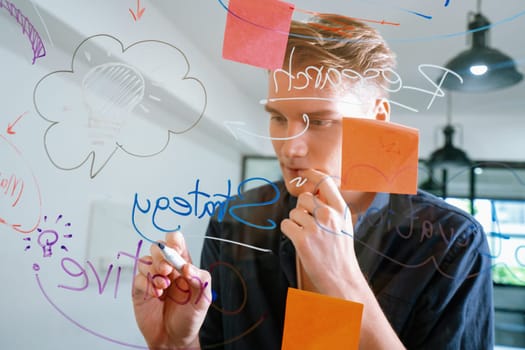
top-left (273, 47), bottom-right (463, 112)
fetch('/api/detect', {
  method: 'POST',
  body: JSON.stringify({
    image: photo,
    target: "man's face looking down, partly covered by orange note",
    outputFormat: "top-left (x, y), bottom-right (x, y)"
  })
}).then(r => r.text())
top-left (266, 67), bottom-right (370, 196)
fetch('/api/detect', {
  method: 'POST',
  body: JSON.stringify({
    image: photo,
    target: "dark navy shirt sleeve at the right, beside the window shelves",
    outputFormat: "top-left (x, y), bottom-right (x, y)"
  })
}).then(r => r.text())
top-left (406, 221), bottom-right (494, 349)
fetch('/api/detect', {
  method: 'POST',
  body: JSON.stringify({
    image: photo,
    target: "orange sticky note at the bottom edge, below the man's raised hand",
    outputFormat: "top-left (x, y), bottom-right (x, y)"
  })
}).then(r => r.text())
top-left (281, 288), bottom-right (363, 350)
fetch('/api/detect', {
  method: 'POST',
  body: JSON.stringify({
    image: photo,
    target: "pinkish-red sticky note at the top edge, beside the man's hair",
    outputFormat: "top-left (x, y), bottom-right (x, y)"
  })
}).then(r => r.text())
top-left (222, 0), bottom-right (294, 69)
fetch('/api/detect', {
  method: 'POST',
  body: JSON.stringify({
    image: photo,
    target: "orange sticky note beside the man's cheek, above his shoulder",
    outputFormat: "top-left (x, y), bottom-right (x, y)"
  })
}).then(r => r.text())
top-left (341, 118), bottom-right (419, 194)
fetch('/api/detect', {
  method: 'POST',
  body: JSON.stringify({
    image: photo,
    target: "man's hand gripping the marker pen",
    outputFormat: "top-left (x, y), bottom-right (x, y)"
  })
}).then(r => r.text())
top-left (132, 232), bottom-right (211, 349)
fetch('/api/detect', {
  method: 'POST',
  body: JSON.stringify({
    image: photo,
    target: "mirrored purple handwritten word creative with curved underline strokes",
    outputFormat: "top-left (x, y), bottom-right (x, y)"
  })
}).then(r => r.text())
top-left (33, 240), bottom-right (266, 349)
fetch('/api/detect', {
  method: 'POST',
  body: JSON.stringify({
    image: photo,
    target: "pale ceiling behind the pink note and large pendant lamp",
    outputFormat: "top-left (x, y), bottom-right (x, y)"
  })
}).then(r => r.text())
top-left (157, 0), bottom-right (525, 123)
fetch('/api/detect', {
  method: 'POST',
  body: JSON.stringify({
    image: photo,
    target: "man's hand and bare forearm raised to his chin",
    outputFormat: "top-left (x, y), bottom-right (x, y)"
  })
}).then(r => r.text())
top-left (281, 170), bottom-right (404, 350)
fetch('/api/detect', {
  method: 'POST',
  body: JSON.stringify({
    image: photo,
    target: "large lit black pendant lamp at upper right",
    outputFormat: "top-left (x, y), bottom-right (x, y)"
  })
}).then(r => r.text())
top-left (438, 0), bottom-right (523, 92)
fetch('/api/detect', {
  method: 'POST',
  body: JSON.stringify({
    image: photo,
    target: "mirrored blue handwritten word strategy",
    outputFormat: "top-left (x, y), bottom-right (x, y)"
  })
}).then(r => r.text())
top-left (131, 177), bottom-right (280, 241)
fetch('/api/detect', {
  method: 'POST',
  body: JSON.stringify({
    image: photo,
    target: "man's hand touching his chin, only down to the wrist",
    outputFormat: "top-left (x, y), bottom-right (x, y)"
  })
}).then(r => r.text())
top-left (281, 169), bottom-right (366, 299)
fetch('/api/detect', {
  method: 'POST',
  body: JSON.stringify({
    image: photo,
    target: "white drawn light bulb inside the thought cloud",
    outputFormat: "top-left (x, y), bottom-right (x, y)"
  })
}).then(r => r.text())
top-left (82, 62), bottom-right (145, 145)
